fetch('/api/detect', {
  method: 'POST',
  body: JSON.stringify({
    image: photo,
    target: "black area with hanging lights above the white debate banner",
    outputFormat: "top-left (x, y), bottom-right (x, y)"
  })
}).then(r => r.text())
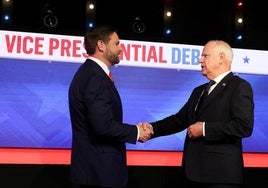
top-left (1, 0), bottom-right (268, 50)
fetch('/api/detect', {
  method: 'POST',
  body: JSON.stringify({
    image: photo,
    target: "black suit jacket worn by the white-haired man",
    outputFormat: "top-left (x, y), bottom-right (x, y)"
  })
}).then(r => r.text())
top-left (152, 73), bottom-right (254, 183)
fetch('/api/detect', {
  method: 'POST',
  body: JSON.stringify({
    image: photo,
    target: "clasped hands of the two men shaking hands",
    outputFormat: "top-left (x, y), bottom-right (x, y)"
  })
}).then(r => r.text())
top-left (137, 122), bottom-right (154, 142)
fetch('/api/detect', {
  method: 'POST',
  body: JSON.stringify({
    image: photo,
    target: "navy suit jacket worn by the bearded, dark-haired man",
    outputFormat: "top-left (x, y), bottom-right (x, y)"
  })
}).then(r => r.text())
top-left (69, 59), bottom-right (137, 187)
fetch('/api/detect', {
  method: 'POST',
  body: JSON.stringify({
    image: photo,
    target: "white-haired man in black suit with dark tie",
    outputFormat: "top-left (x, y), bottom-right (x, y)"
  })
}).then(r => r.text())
top-left (143, 40), bottom-right (254, 188)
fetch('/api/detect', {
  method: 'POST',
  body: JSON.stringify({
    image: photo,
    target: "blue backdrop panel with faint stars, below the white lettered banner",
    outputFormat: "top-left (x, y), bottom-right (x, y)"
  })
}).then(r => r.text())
top-left (0, 58), bottom-right (268, 152)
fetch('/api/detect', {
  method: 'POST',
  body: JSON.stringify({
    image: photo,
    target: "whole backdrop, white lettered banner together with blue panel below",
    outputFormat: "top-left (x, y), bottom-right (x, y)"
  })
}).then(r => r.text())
top-left (0, 30), bottom-right (268, 153)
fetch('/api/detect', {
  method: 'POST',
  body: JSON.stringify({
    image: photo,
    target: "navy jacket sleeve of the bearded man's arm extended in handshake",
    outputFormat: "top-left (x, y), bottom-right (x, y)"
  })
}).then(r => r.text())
top-left (85, 74), bottom-right (138, 143)
